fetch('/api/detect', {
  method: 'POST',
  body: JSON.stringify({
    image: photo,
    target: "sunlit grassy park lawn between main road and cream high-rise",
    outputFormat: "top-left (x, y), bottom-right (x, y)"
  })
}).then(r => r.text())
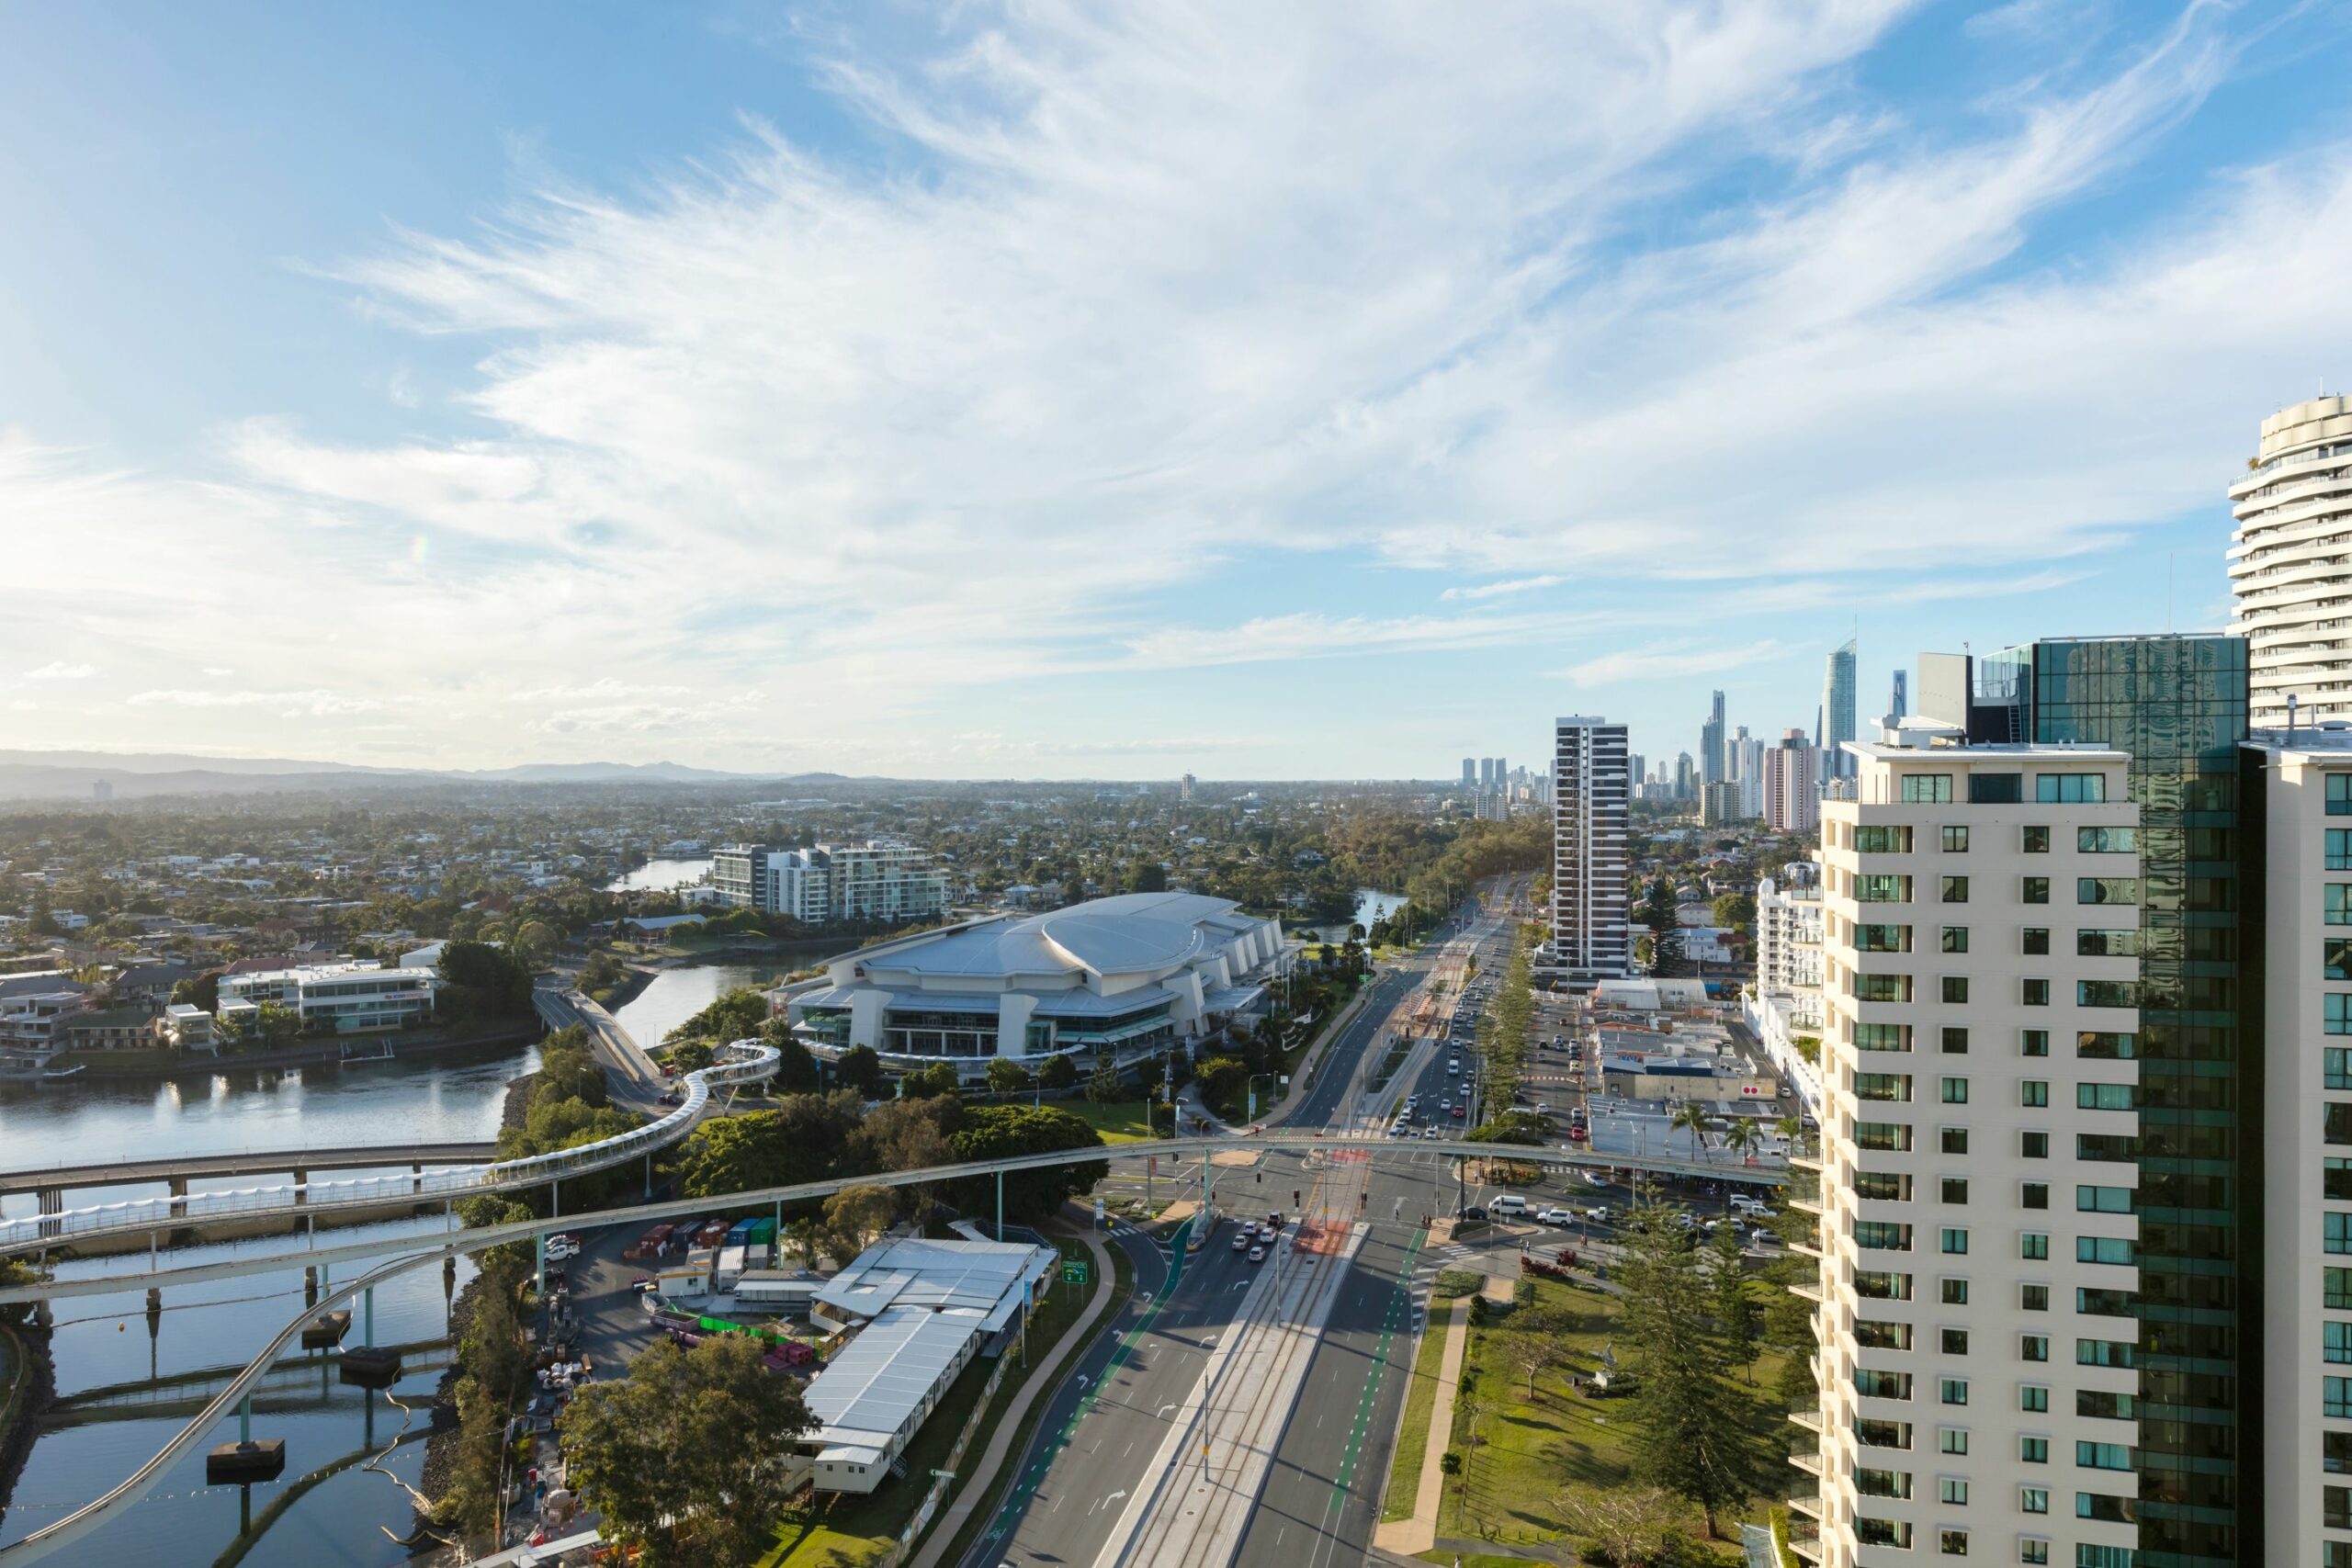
top-left (1383, 1274), bottom-right (1797, 1565)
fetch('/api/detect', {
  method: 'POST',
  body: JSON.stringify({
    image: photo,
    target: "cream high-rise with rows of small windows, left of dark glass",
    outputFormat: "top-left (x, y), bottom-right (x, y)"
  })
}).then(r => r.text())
top-left (1792, 731), bottom-right (2154, 1568)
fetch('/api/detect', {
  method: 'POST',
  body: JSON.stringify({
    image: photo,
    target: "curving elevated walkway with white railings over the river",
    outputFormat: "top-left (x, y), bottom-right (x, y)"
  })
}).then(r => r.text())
top-left (0, 1039), bottom-right (781, 1253)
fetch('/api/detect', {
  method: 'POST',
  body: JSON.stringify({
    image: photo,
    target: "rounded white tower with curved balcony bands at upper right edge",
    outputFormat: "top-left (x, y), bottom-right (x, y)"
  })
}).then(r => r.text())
top-left (2230, 398), bottom-right (2352, 728)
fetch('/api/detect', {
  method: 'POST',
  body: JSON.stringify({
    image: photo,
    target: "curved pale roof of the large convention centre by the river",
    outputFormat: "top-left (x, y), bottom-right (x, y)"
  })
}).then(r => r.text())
top-left (864, 894), bottom-right (1261, 978)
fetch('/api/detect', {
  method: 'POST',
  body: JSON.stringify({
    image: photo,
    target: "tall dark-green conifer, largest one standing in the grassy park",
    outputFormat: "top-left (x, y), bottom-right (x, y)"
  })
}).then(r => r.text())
top-left (1616, 1208), bottom-right (1752, 1538)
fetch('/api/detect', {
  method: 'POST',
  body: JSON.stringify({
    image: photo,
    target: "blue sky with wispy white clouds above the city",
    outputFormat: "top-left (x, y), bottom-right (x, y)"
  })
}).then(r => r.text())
top-left (0, 0), bottom-right (2352, 778)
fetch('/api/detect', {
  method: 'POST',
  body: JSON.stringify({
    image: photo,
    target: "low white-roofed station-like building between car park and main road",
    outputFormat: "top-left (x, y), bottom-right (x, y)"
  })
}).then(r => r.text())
top-left (793, 1236), bottom-right (1061, 1493)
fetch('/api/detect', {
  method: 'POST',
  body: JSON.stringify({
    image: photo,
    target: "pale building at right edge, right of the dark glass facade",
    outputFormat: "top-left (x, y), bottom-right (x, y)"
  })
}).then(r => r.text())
top-left (2244, 728), bottom-right (2352, 1565)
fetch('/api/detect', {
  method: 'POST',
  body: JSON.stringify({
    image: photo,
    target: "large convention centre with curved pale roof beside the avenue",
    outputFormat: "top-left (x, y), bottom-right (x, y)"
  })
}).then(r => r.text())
top-left (783, 894), bottom-right (1284, 1079)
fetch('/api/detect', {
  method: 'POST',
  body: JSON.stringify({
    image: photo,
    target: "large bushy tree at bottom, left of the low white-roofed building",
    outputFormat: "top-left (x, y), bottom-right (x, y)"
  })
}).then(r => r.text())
top-left (562, 1333), bottom-right (816, 1568)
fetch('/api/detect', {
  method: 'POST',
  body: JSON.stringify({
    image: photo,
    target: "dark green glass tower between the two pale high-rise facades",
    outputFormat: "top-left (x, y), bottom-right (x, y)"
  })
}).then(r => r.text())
top-left (2013, 635), bottom-right (2263, 1568)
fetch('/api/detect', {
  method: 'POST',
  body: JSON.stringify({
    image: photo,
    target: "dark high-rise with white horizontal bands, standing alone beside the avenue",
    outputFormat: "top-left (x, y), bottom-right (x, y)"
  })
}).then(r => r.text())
top-left (1543, 717), bottom-right (1633, 985)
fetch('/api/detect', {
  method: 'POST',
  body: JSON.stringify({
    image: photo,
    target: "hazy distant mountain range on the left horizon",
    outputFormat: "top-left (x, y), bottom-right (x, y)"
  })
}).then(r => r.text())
top-left (0, 750), bottom-right (842, 799)
